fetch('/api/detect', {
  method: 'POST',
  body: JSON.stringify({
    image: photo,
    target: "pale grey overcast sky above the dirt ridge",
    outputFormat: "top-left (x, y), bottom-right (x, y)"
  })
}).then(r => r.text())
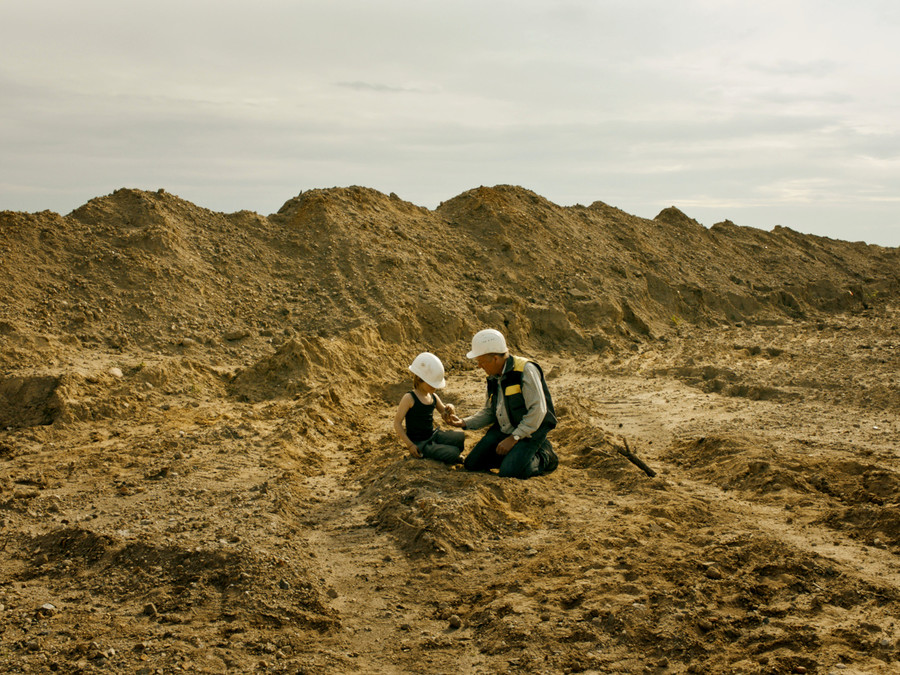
top-left (0, 0), bottom-right (900, 246)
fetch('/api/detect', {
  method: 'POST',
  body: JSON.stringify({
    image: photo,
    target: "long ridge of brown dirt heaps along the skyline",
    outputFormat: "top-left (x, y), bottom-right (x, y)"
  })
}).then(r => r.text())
top-left (0, 186), bottom-right (900, 370)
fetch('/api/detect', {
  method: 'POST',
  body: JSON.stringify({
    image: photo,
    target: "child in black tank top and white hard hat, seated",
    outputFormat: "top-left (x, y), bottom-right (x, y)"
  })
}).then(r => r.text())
top-left (394, 352), bottom-right (466, 464)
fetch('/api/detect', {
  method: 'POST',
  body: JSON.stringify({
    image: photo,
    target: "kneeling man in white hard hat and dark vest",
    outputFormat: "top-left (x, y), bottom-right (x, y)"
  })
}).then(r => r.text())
top-left (450, 328), bottom-right (559, 478)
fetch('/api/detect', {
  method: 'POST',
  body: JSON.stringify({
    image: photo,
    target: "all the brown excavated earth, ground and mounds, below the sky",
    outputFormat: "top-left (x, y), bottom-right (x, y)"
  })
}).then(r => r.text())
top-left (0, 186), bottom-right (900, 675)
